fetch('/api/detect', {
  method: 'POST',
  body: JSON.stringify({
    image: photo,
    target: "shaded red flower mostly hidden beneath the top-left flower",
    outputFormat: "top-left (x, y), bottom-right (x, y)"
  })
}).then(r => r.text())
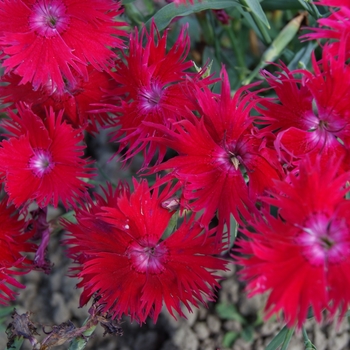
top-left (0, 65), bottom-right (115, 132)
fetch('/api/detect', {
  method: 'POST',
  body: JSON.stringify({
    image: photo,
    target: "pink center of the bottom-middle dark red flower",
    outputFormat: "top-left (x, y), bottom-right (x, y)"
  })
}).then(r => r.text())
top-left (127, 240), bottom-right (168, 274)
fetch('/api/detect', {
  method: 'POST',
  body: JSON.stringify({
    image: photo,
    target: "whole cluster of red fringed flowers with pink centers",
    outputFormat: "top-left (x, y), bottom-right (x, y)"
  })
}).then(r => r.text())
top-left (0, 0), bottom-right (350, 326)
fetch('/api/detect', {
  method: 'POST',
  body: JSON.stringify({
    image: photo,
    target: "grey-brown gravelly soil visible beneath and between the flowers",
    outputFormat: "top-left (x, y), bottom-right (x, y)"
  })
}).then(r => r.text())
top-left (0, 133), bottom-right (350, 350)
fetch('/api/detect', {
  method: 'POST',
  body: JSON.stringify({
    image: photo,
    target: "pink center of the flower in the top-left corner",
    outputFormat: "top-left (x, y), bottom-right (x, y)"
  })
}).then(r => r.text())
top-left (29, 0), bottom-right (69, 37)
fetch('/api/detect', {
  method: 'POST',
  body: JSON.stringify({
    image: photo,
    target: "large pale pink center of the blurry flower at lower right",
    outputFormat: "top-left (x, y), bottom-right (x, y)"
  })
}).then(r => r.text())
top-left (297, 213), bottom-right (350, 266)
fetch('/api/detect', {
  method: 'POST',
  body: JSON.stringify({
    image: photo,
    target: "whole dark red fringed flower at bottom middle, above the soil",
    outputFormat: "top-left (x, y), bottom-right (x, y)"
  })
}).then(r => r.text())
top-left (65, 181), bottom-right (226, 323)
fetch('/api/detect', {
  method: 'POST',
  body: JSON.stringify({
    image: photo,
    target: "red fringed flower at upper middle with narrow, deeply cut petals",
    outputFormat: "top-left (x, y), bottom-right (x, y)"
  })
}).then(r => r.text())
top-left (104, 23), bottom-right (210, 165)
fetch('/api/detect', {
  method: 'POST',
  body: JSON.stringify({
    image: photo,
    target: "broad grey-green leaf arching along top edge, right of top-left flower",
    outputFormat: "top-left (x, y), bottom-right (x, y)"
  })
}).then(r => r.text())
top-left (146, 0), bottom-right (240, 31)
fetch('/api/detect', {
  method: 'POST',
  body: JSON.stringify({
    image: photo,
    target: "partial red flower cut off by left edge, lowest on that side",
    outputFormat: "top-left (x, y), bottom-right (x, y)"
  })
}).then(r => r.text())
top-left (0, 197), bottom-right (35, 305)
